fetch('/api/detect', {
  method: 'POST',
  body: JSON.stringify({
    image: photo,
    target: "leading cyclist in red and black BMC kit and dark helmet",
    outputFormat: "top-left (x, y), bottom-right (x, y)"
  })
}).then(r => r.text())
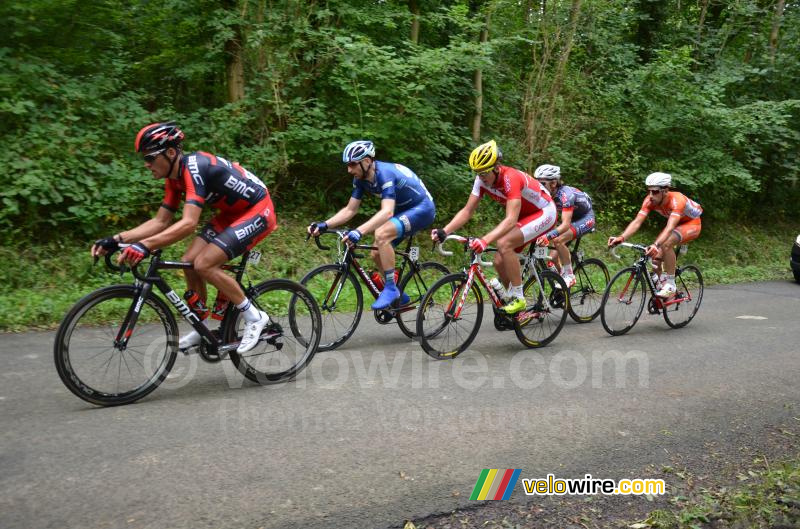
top-left (91, 122), bottom-right (277, 353)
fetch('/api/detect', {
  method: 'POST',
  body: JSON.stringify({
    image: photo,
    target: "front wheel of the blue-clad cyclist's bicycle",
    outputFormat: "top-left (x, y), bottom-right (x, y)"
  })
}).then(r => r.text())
top-left (300, 264), bottom-right (364, 351)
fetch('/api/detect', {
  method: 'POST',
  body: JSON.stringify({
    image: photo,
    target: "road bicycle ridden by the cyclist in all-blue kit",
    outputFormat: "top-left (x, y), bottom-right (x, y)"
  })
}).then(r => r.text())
top-left (300, 230), bottom-right (450, 351)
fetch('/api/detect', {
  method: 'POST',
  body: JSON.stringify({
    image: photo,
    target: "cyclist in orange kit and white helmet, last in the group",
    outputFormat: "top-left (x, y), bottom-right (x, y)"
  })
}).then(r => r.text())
top-left (608, 173), bottom-right (703, 298)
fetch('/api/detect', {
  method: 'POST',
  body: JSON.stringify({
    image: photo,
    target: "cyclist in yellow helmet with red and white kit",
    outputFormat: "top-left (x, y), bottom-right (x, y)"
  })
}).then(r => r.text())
top-left (431, 140), bottom-right (556, 314)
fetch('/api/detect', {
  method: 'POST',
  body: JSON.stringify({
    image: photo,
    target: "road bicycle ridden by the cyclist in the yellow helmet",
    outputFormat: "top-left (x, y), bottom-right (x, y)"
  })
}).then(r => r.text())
top-left (417, 234), bottom-right (569, 359)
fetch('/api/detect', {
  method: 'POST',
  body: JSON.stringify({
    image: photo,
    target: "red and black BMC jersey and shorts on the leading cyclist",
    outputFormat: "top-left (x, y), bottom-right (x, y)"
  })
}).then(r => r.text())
top-left (161, 151), bottom-right (278, 259)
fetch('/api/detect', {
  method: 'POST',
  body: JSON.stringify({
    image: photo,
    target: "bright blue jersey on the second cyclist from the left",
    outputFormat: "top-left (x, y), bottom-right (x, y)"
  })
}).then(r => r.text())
top-left (350, 161), bottom-right (433, 210)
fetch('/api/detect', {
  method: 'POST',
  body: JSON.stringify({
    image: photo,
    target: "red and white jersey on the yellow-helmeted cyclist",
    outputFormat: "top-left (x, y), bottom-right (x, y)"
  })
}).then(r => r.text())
top-left (472, 165), bottom-right (553, 214)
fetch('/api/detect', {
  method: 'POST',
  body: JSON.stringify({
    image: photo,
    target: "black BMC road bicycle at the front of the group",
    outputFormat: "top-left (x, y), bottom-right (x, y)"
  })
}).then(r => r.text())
top-left (54, 244), bottom-right (321, 406)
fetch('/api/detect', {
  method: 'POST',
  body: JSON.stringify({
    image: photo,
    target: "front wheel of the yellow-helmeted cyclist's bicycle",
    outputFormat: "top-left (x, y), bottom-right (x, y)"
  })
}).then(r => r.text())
top-left (417, 273), bottom-right (483, 360)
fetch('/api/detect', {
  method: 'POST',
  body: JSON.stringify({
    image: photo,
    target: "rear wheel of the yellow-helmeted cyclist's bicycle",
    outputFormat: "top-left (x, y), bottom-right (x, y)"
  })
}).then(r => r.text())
top-left (513, 270), bottom-right (569, 348)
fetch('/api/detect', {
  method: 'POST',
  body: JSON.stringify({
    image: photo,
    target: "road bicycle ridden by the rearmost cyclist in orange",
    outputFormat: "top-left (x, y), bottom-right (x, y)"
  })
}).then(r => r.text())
top-left (600, 242), bottom-right (703, 336)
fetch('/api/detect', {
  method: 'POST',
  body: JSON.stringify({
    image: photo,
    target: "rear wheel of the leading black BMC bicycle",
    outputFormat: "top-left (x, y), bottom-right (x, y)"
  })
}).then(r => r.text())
top-left (223, 279), bottom-right (322, 384)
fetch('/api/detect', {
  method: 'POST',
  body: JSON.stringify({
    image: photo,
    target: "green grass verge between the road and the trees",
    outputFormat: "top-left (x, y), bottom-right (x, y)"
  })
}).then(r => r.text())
top-left (0, 218), bottom-right (800, 331)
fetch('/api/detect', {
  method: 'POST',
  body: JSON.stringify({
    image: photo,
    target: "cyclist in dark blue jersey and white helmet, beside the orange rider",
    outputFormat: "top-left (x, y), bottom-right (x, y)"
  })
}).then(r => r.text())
top-left (533, 165), bottom-right (595, 288)
